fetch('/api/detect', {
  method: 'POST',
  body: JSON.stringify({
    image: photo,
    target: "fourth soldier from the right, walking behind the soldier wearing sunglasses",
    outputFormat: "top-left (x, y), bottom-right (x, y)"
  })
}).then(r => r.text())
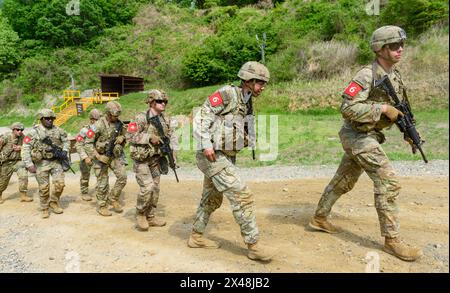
top-left (92, 101), bottom-right (127, 216)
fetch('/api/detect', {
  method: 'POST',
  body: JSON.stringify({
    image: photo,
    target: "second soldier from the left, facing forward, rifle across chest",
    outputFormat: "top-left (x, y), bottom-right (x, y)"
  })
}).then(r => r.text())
top-left (22, 109), bottom-right (69, 219)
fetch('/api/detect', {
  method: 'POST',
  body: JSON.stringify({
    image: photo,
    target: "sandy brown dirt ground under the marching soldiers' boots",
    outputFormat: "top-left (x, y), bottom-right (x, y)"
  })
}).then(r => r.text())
top-left (0, 174), bottom-right (449, 273)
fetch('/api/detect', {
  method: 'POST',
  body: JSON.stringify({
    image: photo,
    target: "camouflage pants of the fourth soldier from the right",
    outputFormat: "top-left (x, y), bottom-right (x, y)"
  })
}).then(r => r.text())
top-left (94, 159), bottom-right (127, 207)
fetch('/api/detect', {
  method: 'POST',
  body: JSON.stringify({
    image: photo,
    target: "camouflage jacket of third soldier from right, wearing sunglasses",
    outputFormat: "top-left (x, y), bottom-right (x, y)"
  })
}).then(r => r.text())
top-left (127, 110), bottom-right (175, 161)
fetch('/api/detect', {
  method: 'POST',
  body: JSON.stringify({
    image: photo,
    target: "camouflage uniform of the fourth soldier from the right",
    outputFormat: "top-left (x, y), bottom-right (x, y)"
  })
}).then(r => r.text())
top-left (93, 102), bottom-right (127, 207)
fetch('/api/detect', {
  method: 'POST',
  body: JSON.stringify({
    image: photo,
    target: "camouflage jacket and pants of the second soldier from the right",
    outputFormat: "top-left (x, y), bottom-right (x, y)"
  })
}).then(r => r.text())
top-left (193, 85), bottom-right (259, 244)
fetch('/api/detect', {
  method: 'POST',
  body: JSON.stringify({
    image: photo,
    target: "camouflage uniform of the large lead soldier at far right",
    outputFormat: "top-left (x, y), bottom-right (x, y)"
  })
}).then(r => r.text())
top-left (316, 62), bottom-right (407, 238)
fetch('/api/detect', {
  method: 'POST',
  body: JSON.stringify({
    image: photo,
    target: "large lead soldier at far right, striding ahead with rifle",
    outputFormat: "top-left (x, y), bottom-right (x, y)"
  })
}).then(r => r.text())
top-left (309, 26), bottom-right (422, 261)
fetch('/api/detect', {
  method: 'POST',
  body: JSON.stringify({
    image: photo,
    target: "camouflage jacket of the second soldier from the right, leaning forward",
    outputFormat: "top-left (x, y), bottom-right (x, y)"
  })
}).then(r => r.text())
top-left (194, 85), bottom-right (253, 156)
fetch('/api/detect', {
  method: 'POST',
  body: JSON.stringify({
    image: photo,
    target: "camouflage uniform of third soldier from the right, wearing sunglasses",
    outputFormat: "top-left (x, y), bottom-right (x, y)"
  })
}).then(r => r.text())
top-left (128, 110), bottom-right (173, 217)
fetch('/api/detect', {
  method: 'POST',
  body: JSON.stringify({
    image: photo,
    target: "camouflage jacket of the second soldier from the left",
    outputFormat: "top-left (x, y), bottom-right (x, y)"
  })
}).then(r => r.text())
top-left (21, 124), bottom-right (70, 168)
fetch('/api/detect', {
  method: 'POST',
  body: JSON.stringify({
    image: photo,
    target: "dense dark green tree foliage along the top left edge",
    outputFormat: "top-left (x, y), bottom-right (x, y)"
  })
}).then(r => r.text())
top-left (3, 0), bottom-right (142, 47)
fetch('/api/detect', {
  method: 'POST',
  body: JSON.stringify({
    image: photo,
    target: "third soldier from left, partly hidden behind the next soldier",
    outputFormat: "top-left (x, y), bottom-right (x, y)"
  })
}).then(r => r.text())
top-left (75, 109), bottom-right (101, 201)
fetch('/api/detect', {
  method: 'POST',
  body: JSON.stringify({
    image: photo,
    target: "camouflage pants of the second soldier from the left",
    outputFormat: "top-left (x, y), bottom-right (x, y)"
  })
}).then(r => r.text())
top-left (36, 160), bottom-right (65, 209)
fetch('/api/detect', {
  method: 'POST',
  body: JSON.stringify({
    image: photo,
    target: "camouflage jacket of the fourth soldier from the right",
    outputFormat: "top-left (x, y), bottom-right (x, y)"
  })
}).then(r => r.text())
top-left (91, 117), bottom-right (126, 155)
